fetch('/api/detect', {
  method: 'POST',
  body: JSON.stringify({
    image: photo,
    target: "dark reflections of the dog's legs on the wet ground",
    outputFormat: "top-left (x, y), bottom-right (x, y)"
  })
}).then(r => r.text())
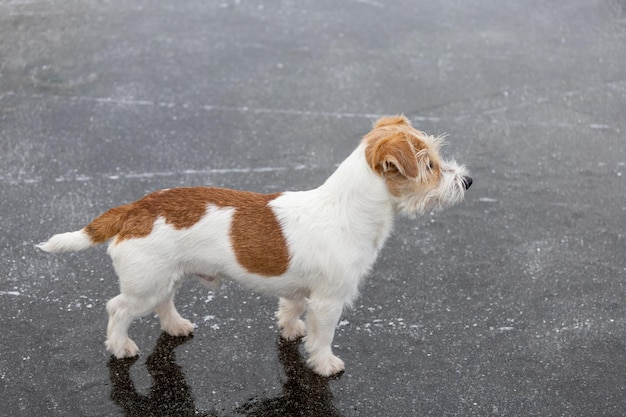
top-left (108, 333), bottom-right (341, 417)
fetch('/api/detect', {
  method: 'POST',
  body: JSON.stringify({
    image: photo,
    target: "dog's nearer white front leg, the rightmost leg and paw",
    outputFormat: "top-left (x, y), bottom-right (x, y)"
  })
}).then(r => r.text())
top-left (304, 296), bottom-right (345, 376)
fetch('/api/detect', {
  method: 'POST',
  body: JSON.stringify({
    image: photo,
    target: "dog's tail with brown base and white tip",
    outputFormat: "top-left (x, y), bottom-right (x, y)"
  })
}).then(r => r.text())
top-left (36, 204), bottom-right (131, 252)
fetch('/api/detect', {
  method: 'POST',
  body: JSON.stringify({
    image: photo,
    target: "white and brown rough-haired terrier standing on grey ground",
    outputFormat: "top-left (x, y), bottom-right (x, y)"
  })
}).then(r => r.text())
top-left (37, 116), bottom-right (472, 376)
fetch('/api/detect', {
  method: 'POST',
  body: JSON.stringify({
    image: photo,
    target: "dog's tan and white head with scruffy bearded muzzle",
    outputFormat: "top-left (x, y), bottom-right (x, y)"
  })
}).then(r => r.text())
top-left (363, 116), bottom-right (472, 216)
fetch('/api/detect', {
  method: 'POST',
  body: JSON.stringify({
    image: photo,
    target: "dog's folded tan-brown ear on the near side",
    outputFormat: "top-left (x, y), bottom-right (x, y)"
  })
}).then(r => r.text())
top-left (366, 134), bottom-right (419, 178)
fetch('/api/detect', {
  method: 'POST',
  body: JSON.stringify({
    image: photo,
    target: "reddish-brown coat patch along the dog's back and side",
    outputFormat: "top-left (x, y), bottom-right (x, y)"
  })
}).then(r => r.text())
top-left (95, 187), bottom-right (290, 277)
